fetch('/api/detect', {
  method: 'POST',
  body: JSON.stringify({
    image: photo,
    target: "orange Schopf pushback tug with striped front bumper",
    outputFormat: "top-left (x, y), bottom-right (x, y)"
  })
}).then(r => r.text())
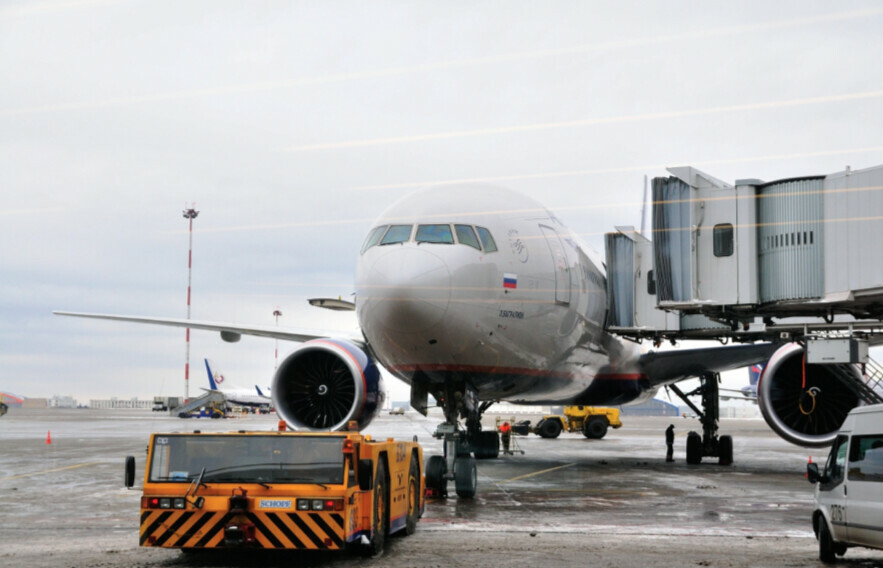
top-left (126, 431), bottom-right (425, 554)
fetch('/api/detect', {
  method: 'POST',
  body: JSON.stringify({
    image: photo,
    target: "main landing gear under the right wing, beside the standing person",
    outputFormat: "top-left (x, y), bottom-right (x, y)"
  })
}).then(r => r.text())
top-left (669, 373), bottom-right (733, 465)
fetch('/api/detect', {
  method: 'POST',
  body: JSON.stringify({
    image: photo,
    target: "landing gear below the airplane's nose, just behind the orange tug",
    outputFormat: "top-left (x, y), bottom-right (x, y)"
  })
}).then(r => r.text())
top-left (426, 384), bottom-right (500, 499)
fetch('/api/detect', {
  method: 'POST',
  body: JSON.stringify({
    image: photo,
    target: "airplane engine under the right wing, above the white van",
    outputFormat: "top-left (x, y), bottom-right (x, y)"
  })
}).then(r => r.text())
top-left (757, 343), bottom-right (861, 448)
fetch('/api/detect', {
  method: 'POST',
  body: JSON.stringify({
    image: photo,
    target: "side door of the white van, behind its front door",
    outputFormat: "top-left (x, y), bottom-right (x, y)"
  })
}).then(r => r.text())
top-left (846, 434), bottom-right (883, 548)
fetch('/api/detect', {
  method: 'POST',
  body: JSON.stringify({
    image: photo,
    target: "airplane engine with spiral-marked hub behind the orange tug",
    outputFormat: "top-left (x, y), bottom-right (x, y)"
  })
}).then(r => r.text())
top-left (272, 339), bottom-right (386, 431)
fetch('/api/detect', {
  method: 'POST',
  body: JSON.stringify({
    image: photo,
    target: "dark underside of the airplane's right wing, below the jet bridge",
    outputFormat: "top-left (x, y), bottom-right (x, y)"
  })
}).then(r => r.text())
top-left (638, 343), bottom-right (780, 386)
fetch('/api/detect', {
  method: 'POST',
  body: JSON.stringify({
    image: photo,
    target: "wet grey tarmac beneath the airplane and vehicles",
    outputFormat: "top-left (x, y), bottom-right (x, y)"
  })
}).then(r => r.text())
top-left (0, 409), bottom-right (883, 568)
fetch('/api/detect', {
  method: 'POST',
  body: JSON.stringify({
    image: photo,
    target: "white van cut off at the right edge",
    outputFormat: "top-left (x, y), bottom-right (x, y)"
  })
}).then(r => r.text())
top-left (806, 404), bottom-right (883, 562)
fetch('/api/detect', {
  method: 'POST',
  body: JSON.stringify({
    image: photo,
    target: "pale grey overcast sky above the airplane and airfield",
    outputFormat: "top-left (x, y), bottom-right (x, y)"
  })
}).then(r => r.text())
top-left (0, 0), bottom-right (883, 402)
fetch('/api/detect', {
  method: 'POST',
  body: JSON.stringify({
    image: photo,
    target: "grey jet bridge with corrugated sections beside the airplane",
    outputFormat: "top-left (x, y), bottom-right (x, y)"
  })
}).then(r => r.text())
top-left (606, 162), bottom-right (883, 341)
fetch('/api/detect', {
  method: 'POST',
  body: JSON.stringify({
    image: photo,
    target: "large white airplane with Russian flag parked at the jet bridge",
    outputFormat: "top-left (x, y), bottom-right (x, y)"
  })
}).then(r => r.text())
top-left (56, 185), bottom-right (858, 497)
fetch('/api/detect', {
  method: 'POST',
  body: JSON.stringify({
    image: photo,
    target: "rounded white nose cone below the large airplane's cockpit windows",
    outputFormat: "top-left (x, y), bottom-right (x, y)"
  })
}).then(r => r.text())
top-left (359, 245), bottom-right (451, 333)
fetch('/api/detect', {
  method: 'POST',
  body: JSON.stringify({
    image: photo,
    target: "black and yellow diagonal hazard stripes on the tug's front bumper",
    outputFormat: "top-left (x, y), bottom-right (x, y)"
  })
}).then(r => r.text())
top-left (140, 510), bottom-right (344, 550)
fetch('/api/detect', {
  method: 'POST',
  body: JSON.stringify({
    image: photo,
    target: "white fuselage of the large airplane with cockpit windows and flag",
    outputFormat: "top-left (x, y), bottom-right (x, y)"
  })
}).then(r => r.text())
top-left (356, 186), bottom-right (652, 404)
